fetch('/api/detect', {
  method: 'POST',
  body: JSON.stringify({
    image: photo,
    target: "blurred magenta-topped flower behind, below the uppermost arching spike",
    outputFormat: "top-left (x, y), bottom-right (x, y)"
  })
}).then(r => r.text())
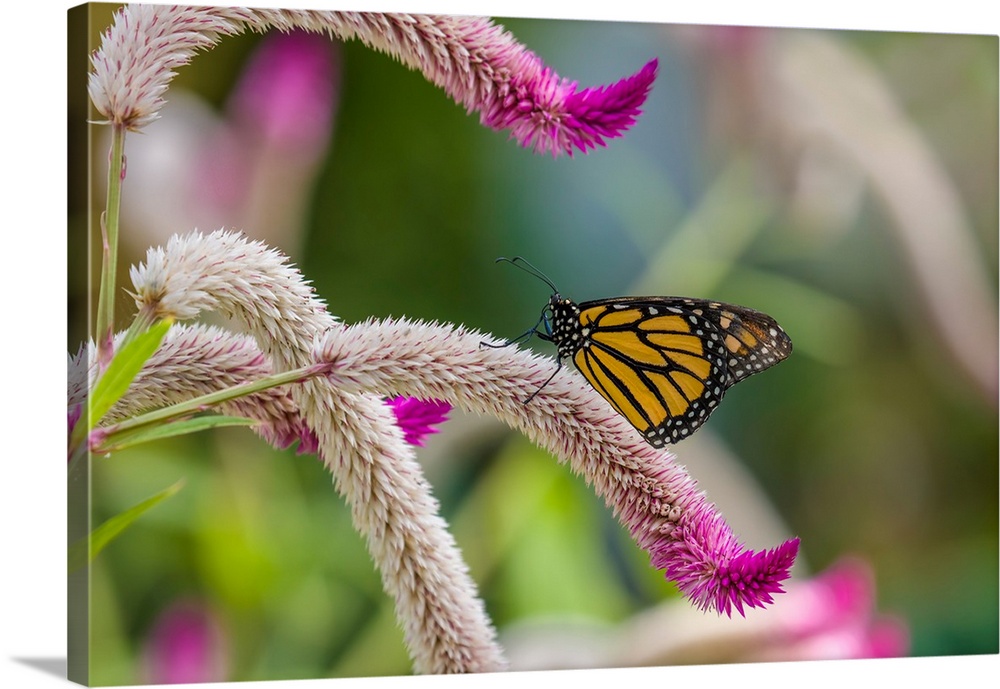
top-left (192, 31), bottom-right (340, 236)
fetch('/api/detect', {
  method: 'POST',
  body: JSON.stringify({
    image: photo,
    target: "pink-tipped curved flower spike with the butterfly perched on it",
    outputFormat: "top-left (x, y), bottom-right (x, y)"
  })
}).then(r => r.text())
top-left (316, 320), bottom-right (798, 615)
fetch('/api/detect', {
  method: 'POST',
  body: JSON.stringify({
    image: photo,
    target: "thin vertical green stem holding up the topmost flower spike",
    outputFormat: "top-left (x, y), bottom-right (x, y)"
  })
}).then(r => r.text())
top-left (95, 124), bottom-right (125, 371)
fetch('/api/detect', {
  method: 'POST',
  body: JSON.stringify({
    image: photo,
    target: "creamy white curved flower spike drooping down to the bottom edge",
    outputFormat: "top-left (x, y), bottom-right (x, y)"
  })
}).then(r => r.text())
top-left (132, 232), bottom-right (505, 673)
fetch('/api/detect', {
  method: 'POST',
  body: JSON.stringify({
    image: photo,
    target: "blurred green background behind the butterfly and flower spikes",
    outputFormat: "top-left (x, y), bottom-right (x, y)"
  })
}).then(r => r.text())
top-left (68, 5), bottom-right (998, 684)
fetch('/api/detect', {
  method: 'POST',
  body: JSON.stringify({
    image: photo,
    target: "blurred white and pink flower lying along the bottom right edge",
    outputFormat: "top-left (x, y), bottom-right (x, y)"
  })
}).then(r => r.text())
top-left (504, 558), bottom-right (910, 670)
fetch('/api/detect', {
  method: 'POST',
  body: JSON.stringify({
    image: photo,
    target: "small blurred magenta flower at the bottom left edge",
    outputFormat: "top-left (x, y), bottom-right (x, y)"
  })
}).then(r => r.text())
top-left (144, 600), bottom-right (228, 684)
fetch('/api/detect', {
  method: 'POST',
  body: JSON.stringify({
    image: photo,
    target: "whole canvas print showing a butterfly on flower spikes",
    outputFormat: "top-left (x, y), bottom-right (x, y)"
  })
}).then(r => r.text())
top-left (67, 3), bottom-right (998, 686)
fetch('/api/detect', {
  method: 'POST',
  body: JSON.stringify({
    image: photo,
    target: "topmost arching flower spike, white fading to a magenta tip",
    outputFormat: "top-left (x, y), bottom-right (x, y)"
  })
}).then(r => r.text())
top-left (89, 5), bottom-right (658, 156)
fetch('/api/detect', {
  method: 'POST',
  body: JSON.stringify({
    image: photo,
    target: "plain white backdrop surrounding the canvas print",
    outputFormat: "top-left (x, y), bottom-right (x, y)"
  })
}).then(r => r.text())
top-left (0, 0), bottom-right (1000, 689)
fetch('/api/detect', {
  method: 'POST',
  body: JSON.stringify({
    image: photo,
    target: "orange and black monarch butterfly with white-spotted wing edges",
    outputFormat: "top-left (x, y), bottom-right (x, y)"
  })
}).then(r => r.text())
top-left (497, 256), bottom-right (792, 447)
